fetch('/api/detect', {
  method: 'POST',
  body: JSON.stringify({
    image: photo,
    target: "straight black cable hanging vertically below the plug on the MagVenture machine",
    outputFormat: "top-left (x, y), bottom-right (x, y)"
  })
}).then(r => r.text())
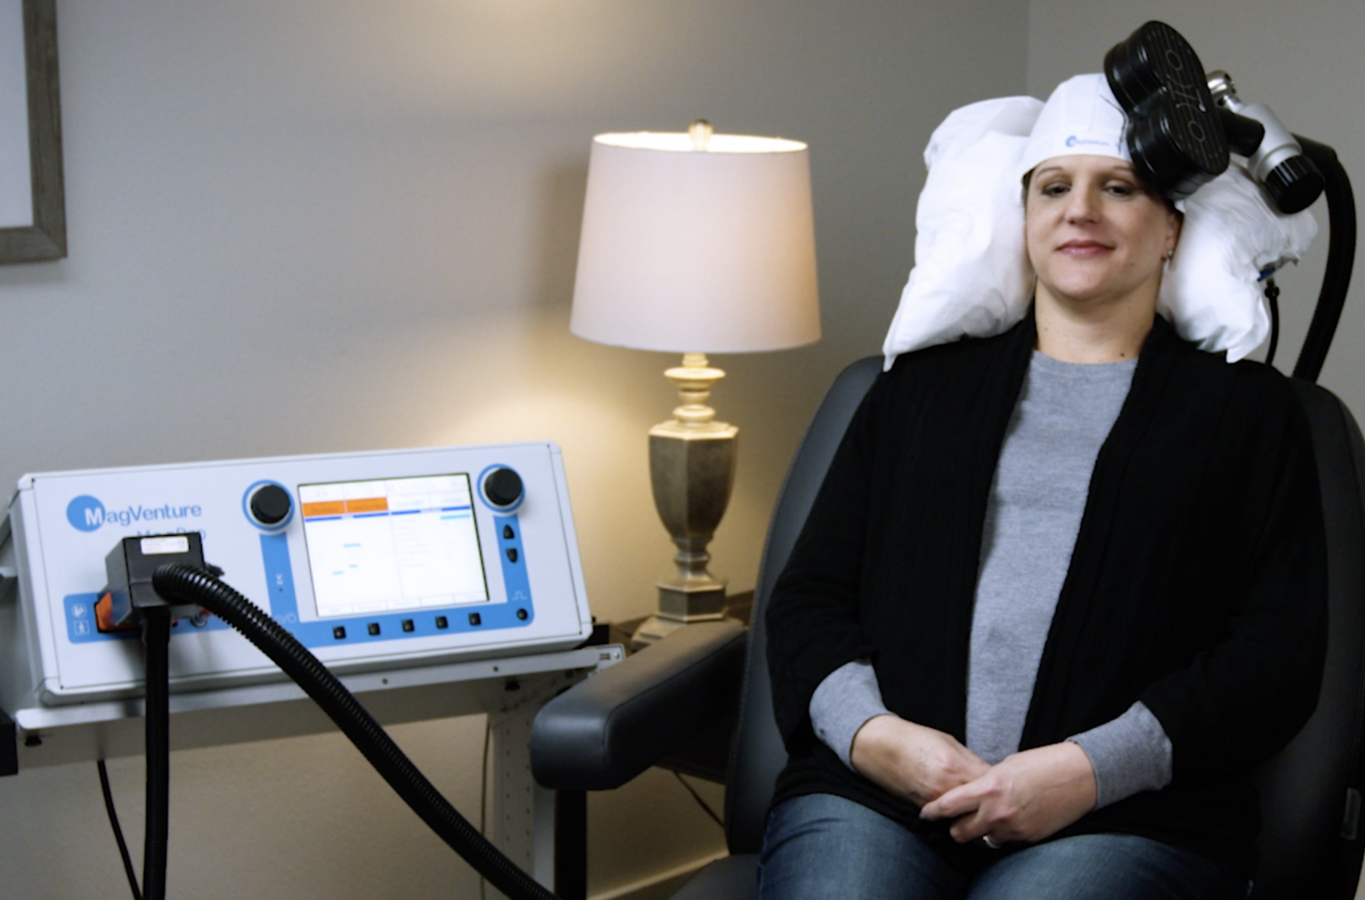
top-left (142, 606), bottom-right (171, 900)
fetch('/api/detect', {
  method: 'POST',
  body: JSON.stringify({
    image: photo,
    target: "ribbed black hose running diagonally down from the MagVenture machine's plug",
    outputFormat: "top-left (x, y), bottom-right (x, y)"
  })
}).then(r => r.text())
top-left (152, 565), bottom-right (557, 900)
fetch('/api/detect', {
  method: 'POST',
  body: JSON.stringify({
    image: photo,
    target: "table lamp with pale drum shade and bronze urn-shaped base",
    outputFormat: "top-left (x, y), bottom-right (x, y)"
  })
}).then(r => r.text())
top-left (569, 120), bottom-right (820, 646)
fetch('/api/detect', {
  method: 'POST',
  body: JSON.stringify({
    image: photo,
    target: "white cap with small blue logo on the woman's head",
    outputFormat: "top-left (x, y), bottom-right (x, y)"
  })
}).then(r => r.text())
top-left (1018, 74), bottom-right (1133, 179)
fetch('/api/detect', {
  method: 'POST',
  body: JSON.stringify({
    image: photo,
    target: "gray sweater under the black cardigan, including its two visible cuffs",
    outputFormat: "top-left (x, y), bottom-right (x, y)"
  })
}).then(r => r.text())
top-left (809, 351), bottom-right (1171, 806)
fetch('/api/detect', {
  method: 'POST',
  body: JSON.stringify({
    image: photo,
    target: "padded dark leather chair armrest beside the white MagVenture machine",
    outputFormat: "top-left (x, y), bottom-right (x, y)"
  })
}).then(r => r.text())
top-left (531, 621), bottom-right (748, 791)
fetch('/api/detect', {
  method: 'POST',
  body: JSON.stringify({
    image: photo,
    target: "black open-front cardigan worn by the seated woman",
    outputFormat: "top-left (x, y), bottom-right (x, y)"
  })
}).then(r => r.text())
top-left (767, 317), bottom-right (1327, 873)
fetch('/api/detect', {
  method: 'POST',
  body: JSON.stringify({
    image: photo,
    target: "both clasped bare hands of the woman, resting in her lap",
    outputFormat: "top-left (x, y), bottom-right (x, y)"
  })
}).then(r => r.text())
top-left (849, 716), bottom-right (1096, 845)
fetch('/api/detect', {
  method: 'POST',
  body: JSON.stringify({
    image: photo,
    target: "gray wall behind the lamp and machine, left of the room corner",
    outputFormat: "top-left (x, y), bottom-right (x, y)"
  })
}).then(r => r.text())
top-left (0, 0), bottom-right (1028, 899)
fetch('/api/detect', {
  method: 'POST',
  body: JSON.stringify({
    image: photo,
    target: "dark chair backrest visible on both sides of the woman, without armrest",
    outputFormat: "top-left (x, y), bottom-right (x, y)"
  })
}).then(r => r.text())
top-left (726, 358), bottom-right (1365, 900)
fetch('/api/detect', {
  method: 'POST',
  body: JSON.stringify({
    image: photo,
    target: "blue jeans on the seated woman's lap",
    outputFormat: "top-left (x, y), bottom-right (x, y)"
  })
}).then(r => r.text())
top-left (759, 793), bottom-right (1250, 900)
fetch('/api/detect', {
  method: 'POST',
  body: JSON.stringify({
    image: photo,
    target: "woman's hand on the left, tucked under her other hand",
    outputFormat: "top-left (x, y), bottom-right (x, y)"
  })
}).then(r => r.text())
top-left (849, 716), bottom-right (990, 807)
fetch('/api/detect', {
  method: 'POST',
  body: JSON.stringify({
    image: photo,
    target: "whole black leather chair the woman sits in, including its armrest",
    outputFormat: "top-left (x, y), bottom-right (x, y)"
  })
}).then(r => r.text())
top-left (531, 358), bottom-right (1365, 900)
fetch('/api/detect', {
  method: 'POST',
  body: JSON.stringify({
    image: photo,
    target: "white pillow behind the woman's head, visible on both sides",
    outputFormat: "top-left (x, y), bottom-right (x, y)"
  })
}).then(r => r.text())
top-left (882, 106), bottom-right (1317, 369)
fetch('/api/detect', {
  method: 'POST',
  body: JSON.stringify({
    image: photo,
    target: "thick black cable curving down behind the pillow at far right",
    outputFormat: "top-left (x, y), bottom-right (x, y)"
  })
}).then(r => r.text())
top-left (1294, 135), bottom-right (1355, 381)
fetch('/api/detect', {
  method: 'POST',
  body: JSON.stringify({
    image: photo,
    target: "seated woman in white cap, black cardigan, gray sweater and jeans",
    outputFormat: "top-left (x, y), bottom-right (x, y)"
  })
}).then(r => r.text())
top-left (759, 76), bottom-right (1325, 900)
